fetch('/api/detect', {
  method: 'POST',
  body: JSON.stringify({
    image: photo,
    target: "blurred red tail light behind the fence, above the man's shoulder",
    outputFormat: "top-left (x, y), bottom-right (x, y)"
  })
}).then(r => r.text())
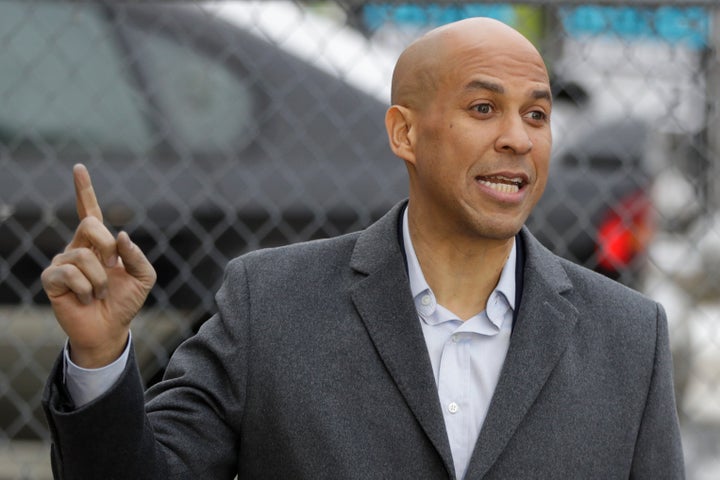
top-left (597, 191), bottom-right (655, 272)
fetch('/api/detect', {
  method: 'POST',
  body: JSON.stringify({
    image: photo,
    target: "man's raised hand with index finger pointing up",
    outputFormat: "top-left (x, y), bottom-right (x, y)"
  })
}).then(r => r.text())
top-left (41, 165), bottom-right (157, 368)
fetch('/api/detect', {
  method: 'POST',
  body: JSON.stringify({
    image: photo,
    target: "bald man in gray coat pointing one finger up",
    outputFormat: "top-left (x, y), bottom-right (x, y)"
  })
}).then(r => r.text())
top-left (42, 18), bottom-right (683, 479)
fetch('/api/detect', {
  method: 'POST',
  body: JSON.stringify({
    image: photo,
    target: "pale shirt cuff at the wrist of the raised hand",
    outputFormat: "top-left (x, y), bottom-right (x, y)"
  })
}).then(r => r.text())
top-left (63, 333), bottom-right (132, 408)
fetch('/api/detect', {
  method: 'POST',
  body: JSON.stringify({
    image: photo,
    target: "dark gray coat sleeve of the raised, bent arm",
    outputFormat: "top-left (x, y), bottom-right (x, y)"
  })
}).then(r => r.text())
top-left (43, 262), bottom-right (248, 480)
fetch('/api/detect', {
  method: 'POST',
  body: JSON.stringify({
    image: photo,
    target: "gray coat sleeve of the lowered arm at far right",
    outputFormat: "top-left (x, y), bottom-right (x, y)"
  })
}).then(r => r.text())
top-left (630, 305), bottom-right (685, 480)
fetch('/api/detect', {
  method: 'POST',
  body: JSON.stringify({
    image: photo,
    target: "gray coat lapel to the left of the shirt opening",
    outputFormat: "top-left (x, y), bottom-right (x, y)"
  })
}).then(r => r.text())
top-left (351, 205), bottom-right (454, 472)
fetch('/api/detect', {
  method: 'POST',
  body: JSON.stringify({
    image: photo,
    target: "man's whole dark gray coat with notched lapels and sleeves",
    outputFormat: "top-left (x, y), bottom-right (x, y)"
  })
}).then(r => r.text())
top-left (44, 201), bottom-right (684, 480)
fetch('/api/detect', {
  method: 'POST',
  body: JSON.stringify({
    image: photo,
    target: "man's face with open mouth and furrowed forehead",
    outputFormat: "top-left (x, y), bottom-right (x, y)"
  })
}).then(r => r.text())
top-left (409, 35), bottom-right (552, 240)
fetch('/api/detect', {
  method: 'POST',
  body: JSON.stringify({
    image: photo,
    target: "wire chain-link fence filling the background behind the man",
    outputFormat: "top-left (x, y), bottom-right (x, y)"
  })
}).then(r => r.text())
top-left (0, 0), bottom-right (720, 479)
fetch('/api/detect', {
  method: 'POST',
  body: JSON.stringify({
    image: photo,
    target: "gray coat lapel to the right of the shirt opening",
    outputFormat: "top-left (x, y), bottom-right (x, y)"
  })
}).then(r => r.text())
top-left (466, 229), bottom-right (578, 478)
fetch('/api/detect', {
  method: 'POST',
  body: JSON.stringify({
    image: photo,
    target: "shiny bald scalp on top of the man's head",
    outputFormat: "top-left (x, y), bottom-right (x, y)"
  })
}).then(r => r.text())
top-left (391, 17), bottom-right (544, 108)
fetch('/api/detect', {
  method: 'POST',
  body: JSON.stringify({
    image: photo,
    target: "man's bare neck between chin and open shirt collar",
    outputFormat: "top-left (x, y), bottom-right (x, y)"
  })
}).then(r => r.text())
top-left (408, 212), bottom-right (514, 320)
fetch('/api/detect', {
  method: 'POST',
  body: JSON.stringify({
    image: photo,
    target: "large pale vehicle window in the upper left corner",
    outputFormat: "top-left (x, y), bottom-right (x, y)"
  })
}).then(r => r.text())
top-left (0, 2), bottom-right (152, 151)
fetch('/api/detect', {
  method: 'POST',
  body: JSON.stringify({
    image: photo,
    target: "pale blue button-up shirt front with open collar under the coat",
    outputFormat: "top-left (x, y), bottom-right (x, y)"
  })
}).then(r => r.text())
top-left (403, 209), bottom-right (517, 479)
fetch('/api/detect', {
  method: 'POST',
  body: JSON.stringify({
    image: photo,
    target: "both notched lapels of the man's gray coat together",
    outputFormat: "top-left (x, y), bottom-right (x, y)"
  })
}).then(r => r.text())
top-left (350, 202), bottom-right (577, 478)
